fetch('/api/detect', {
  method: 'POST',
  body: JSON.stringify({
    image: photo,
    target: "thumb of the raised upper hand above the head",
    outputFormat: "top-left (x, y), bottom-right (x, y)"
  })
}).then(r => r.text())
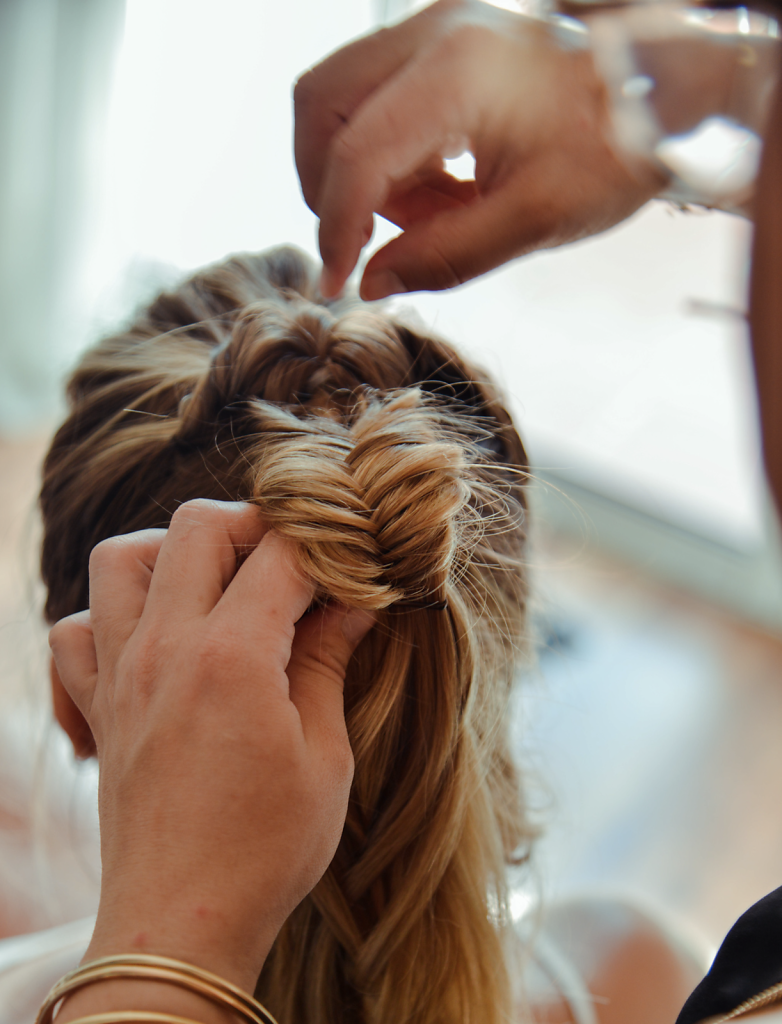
top-left (360, 179), bottom-right (554, 301)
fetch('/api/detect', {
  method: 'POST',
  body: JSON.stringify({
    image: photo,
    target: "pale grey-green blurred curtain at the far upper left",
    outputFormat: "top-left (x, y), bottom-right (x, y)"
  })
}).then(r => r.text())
top-left (0, 0), bottom-right (125, 432)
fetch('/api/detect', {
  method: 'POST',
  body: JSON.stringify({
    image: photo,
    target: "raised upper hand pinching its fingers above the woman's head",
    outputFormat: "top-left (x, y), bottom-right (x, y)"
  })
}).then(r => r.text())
top-left (294, 0), bottom-right (663, 299)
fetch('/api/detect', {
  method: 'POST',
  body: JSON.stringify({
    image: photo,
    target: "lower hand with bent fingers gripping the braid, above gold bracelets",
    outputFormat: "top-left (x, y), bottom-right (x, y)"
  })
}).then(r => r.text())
top-left (50, 501), bottom-right (372, 1009)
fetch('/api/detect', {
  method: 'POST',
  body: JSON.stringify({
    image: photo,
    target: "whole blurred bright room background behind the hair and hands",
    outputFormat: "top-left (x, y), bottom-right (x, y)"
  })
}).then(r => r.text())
top-left (0, 0), bottom-right (782, 962)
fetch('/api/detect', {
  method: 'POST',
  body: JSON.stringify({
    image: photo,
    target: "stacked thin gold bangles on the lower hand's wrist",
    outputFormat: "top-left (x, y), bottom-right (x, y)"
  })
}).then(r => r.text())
top-left (36, 954), bottom-right (276, 1024)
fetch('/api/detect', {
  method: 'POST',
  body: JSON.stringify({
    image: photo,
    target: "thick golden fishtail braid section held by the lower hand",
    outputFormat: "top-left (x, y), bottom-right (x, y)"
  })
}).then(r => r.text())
top-left (250, 389), bottom-right (470, 609)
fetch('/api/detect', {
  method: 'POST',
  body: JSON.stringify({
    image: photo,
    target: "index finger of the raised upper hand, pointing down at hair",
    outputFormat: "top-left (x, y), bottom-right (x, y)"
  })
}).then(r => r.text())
top-left (318, 39), bottom-right (473, 297)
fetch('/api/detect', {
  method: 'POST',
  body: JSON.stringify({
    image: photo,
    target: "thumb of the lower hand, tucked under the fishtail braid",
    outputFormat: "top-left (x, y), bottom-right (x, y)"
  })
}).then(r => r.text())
top-left (288, 604), bottom-right (375, 736)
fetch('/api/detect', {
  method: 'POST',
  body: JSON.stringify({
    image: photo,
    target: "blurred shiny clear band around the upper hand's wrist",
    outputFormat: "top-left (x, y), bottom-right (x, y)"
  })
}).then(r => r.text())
top-left (589, 3), bottom-right (780, 210)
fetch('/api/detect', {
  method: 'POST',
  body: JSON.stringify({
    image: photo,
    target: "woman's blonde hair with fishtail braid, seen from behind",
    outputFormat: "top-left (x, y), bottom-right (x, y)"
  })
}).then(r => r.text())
top-left (41, 249), bottom-right (532, 1024)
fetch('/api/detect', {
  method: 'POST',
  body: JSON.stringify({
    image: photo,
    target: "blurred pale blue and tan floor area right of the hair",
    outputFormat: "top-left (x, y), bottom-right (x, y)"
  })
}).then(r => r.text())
top-left (519, 537), bottom-right (782, 942)
